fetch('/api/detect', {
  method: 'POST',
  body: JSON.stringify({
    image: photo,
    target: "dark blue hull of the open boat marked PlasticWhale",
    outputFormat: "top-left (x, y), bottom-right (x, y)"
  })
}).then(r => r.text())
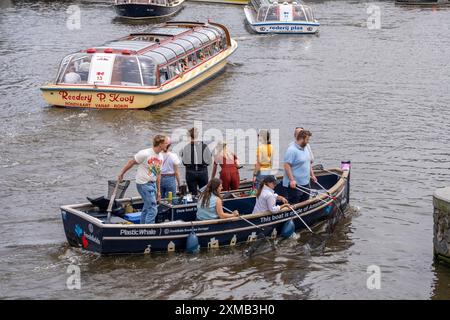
top-left (61, 165), bottom-right (350, 254)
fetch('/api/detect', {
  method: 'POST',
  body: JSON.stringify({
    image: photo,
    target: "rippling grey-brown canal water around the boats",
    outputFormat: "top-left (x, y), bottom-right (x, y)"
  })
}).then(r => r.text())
top-left (0, 0), bottom-right (450, 299)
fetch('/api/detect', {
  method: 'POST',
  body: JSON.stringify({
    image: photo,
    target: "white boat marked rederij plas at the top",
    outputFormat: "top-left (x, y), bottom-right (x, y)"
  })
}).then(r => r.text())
top-left (244, 0), bottom-right (320, 34)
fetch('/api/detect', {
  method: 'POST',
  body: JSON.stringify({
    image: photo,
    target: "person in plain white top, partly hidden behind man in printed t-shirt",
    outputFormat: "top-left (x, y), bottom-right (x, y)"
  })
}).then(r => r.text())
top-left (161, 138), bottom-right (181, 198)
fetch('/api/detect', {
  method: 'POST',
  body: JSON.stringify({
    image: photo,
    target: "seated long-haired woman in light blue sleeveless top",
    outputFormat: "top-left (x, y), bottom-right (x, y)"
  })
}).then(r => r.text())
top-left (197, 178), bottom-right (239, 220)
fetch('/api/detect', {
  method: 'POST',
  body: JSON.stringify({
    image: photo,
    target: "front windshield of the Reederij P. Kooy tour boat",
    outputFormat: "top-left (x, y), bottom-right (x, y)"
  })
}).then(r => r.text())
top-left (56, 53), bottom-right (156, 86)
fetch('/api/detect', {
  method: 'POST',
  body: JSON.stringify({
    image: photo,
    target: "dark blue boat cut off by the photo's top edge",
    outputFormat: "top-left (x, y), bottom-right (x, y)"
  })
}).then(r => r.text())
top-left (114, 0), bottom-right (184, 19)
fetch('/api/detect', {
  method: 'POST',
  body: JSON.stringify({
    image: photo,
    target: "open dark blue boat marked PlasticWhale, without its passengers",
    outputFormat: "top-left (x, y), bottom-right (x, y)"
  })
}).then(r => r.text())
top-left (61, 162), bottom-right (350, 254)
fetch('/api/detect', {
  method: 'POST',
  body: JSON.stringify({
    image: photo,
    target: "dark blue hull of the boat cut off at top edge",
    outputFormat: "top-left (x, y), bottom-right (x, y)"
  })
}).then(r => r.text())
top-left (114, 3), bottom-right (182, 19)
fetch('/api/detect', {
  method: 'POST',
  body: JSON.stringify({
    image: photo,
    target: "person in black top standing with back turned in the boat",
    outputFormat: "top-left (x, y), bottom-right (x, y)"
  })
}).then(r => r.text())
top-left (181, 128), bottom-right (212, 195)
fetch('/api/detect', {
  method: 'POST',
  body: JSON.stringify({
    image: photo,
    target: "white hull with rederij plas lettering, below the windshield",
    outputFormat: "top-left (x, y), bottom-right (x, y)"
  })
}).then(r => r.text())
top-left (244, 6), bottom-right (320, 34)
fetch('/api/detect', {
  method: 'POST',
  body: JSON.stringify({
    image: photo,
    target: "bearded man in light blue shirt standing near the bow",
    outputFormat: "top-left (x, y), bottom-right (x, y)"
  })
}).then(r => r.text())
top-left (283, 130), bottom-right (315, 203)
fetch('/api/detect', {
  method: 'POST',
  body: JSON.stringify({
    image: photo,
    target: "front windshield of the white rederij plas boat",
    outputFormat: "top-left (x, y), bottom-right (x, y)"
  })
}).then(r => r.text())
top-left (256, 2), bottom-right (315, 22)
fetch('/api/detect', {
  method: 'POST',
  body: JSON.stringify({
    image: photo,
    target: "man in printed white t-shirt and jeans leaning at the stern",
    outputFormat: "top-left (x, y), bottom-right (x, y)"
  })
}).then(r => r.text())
top-left (117, 135), bottom-right (168, 224)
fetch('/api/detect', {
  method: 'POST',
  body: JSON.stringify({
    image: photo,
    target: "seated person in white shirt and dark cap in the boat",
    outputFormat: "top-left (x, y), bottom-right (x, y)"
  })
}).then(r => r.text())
top-left (252, 176), bottom-right (289, 213)
